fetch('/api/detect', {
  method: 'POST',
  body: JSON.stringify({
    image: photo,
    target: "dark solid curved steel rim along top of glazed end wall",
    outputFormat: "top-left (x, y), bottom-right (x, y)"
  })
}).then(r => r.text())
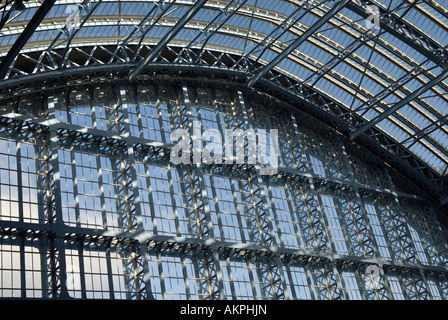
top-left (0, 43), bottom-right (442, 212)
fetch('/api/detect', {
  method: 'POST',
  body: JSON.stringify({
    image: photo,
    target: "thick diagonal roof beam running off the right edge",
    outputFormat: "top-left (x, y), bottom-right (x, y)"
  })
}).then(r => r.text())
top-left (350, 69), bottom-right (448, 139)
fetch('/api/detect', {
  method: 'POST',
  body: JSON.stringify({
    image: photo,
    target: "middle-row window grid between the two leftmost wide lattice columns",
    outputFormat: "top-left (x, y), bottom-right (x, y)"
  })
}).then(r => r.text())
top-left (58, 140), bottom-right (128, 230)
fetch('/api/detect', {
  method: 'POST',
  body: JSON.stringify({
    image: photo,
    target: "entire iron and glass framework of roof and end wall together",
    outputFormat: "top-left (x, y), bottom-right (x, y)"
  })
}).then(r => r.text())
top-left (0, 0), bottom-right (448, 300)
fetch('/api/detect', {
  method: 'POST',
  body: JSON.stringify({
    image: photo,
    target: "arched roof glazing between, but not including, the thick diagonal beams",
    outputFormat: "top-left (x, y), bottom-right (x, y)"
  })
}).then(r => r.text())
top-left (0, 0), bottom-right (448, 176)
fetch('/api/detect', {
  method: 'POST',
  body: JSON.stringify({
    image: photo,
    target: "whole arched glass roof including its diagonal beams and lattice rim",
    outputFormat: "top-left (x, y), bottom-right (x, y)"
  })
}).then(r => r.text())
top-left (0, 0), bottom-right (448, 202)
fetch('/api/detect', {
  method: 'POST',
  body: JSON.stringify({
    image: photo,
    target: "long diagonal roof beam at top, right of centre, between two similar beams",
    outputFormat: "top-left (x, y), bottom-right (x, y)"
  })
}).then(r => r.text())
top-left (247, 0), bottom-right (349, 88)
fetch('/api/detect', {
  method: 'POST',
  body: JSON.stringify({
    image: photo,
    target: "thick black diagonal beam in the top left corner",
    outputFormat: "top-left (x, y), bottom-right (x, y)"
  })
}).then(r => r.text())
top-left (0, 0), bottom-right (56, 79)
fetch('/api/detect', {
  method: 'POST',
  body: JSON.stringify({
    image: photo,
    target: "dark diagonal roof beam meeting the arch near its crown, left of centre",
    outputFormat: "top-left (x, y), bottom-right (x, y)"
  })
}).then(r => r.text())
top-left (129, 0), bottom-right (207, 81)
